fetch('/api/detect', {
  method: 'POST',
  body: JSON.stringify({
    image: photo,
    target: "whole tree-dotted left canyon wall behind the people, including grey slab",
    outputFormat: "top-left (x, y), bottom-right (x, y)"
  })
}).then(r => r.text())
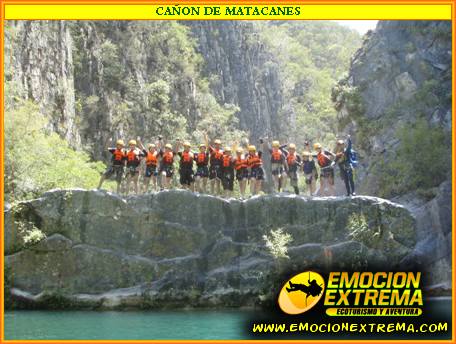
top-left (6, 21), bottom-right (282, 156)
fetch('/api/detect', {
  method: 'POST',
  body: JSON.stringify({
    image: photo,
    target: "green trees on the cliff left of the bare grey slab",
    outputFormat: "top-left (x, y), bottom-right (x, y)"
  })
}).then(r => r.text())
top-left (72, 21), bottom-right (247, 151)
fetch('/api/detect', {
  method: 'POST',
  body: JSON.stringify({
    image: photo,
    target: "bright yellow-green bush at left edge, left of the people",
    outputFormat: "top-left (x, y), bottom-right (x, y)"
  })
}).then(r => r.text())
top-left (4, 92), bottom-right (105, 202)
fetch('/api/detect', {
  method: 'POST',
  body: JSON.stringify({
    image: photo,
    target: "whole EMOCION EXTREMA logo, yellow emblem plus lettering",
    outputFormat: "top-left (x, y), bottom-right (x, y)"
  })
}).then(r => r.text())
top-left (278, 271), bottom-right (423, 316)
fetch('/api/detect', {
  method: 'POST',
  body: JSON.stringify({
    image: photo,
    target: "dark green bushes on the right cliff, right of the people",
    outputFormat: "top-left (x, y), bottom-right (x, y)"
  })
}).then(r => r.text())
top-left (374, 119), bottom-right (451, 197)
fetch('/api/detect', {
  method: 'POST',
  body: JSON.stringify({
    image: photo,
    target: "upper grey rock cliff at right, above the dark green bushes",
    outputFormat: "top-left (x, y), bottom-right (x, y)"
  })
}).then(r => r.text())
top-left (333, 21), bottom-right (451, 195)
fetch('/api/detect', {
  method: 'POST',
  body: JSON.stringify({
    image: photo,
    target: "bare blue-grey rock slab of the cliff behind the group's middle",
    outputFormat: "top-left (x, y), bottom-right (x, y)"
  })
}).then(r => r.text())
top-left (189, 21), bottom-right (283, 142)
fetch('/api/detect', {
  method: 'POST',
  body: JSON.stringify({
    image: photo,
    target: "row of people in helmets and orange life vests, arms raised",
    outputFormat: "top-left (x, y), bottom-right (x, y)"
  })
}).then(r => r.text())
top-left (98, 136), bottom-right (355, 198)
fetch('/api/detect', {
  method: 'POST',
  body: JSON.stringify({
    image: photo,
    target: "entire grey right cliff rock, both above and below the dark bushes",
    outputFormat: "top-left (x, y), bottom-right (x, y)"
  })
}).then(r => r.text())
top-left (333, 21), bottom-right (452, 288)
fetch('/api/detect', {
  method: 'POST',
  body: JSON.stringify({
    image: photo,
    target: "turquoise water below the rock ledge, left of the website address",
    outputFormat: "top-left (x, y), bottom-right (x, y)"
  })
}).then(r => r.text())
top-left (5, 310), bottom-right (252, 339)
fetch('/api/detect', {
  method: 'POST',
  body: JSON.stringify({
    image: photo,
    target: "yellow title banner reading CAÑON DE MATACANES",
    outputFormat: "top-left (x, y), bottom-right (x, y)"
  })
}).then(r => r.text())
top-left (5, 4), bottom-right (452, 20)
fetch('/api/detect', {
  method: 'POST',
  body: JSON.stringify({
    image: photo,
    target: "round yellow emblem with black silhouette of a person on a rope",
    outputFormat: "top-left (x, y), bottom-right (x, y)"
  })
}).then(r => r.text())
top-left (278, 271), bottom-right (325, 314)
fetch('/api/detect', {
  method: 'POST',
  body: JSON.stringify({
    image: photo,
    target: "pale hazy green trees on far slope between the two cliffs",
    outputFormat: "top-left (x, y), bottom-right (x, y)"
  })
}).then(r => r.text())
top-left (261, 21), bottom-right (361, 147)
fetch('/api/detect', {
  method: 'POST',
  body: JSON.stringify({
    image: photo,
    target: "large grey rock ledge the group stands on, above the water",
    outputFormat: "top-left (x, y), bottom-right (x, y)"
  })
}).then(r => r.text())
top-left (5, 189), bottom-right (416, 309)
